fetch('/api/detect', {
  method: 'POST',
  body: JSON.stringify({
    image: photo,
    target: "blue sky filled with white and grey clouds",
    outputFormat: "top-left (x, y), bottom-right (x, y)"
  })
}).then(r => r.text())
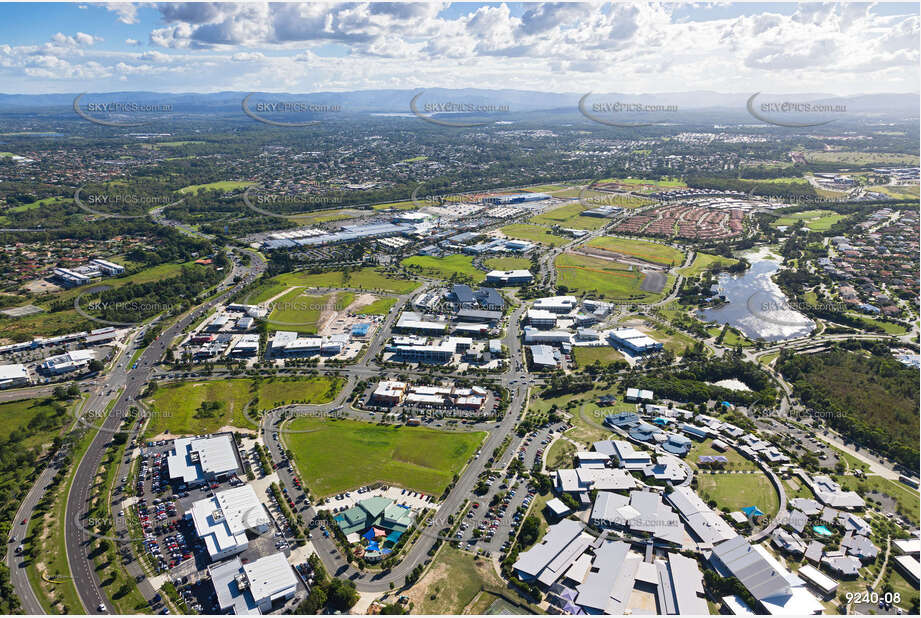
top-left (0, 2), bottom-right (921, 95)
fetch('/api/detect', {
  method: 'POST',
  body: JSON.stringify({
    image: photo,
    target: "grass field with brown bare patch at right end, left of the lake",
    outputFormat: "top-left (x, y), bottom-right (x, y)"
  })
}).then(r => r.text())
top-left (554, 253), bottom-right (673, 302)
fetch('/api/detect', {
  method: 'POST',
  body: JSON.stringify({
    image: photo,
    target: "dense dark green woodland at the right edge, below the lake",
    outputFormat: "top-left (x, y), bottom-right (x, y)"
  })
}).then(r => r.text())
top-left (777, 342), bottom-right (921, 470)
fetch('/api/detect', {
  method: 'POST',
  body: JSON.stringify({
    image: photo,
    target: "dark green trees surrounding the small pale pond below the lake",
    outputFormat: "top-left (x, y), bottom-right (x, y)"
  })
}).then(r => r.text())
top-left (624, 358), bottom-right (777, 406)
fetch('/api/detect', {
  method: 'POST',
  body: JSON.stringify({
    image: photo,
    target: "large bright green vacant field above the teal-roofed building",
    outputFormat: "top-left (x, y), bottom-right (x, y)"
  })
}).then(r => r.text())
top-left (285, 417), bottom-right (486, 496)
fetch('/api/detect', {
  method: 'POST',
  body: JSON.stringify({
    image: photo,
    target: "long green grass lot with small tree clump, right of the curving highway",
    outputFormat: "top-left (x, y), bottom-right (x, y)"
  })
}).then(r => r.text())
top-left (146, 376), bottom-right (343, 436)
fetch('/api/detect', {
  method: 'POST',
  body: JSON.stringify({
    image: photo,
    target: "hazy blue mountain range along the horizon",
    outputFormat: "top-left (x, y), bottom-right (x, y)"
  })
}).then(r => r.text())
top-left (0, 88), bottom-right (921, 118)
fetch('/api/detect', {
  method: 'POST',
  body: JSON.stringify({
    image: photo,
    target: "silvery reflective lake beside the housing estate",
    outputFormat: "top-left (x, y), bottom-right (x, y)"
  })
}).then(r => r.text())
top-left (700, 251), bottom-right (815, 341)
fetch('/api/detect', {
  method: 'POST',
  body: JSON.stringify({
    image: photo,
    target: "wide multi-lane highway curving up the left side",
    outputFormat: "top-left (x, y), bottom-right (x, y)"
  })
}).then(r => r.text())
top-left (65, 253), bottom-right (265, 614)
